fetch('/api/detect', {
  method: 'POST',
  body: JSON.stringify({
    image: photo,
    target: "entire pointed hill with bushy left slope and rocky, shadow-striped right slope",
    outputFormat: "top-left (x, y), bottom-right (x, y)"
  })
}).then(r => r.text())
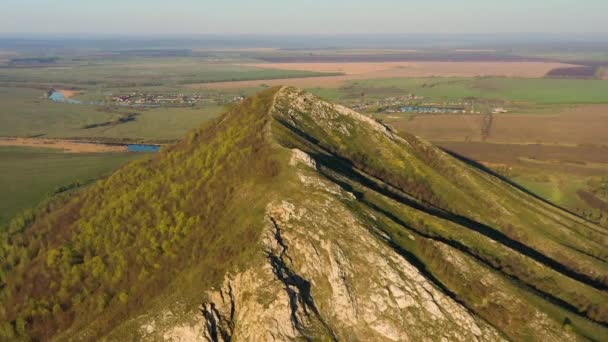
top-left (0, 87), bottom-right (608, 341)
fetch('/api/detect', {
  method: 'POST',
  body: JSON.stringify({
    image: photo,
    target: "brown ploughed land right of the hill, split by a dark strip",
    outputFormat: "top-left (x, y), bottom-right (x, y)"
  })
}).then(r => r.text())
top-left (386, 105), bottom-right (608, 146)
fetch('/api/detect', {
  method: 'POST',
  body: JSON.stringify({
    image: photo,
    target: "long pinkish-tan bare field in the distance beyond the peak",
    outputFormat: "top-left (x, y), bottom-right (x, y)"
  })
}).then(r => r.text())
top-left (190, 61), bottom-right (574, 89)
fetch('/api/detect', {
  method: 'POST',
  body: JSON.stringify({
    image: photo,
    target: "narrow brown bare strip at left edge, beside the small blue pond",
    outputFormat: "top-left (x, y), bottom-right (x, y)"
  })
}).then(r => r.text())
top-left (0, 138), bottom-right (127, 153)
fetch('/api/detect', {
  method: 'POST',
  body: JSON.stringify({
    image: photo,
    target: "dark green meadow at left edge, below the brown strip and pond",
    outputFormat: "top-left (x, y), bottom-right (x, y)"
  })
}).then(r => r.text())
top-left (0, 147), bottom-right (143, 226)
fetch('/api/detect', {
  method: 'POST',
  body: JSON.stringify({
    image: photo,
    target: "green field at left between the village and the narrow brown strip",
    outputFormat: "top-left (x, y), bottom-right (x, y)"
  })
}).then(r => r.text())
top-left (0, 87), bottom-right (223, 140)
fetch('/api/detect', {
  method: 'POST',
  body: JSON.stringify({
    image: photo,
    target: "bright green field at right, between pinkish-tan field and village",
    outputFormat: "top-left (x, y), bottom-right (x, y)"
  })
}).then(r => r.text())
top-left (342, 78), bottom-right (608, 105)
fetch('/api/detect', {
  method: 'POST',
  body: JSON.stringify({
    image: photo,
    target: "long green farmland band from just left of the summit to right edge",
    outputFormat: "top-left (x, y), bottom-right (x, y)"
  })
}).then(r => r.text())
top-left (188, 74), bottom-right (608, 106)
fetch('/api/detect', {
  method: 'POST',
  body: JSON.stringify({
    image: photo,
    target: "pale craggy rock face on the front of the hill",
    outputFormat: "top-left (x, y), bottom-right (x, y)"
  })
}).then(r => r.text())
top-left (157, 154), bottom-right (501, 341)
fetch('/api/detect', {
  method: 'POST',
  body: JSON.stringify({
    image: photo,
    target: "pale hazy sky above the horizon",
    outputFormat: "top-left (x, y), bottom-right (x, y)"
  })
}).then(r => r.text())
top-left (0, 0), bottom-right (608, 34)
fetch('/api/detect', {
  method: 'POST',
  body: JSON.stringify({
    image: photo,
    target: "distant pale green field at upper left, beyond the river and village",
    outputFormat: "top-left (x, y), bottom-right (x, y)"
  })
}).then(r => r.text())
top-left (0, 57), bottom-right (336, 88)
